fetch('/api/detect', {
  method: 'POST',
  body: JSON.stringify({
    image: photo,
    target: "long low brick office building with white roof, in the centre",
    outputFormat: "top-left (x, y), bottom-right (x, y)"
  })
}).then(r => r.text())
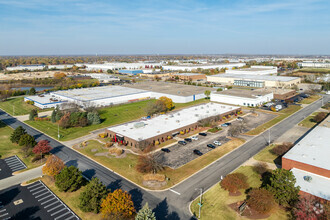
top-left (106, 103), bottom-right (241, 147)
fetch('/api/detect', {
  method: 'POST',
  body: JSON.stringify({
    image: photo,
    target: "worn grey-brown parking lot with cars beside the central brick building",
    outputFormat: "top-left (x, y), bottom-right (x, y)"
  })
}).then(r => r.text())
top-left (154, 111), bottom-right (277, 169)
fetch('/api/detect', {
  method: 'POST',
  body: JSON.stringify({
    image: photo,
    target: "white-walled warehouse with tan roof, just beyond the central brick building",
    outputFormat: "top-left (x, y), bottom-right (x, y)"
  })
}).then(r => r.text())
top-left (210, 89), bottom-right (274, 107)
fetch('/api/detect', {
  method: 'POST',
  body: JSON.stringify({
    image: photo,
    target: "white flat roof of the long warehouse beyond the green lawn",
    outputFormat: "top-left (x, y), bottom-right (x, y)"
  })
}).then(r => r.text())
top-left (53, 86), bottom-right (147, 101)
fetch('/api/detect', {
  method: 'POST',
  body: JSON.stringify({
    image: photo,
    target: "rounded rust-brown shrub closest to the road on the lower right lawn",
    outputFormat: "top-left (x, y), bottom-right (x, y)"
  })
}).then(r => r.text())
top-left (220, 173), bottom-right (249, 193)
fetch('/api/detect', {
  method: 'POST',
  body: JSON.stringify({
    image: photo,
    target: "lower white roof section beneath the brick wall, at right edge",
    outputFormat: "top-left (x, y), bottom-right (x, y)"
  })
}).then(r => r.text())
top-left (291, 168), bottom-right (330, 200)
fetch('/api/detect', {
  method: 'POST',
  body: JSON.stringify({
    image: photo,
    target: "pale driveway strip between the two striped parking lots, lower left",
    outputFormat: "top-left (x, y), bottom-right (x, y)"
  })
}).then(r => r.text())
top-left (0, 166), bottom-right (42, 190)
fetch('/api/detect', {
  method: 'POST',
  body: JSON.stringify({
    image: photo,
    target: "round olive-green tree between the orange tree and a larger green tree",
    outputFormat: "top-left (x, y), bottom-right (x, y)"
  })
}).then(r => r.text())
top-left (55, 166), bottom-right (84, 192)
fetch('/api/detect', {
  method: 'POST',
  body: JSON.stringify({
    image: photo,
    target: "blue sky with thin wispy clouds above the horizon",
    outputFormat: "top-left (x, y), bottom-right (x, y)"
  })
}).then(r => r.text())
top-left (0, 0), bottom-right (330, 55)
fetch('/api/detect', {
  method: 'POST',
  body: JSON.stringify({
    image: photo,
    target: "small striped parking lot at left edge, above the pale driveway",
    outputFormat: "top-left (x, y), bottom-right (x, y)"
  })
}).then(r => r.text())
top-left (0, 155), bottom-right (26, 179)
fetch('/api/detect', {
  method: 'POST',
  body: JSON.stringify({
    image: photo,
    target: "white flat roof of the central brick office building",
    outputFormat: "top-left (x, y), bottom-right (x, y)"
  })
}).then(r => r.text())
top-left (108, 103), bottom-right (238, 141)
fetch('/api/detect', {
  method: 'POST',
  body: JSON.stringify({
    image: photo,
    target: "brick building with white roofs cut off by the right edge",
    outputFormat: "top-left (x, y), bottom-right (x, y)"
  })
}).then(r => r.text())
top-left (282, 116), bottom-right (330, 200)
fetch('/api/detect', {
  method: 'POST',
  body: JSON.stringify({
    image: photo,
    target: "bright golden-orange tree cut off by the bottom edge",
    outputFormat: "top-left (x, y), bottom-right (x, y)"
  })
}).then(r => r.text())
top-left (101, 189), bottom-right (135, 219)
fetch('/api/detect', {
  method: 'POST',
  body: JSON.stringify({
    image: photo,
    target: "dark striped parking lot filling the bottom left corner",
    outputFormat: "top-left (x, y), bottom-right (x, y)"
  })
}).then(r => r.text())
top-left (0, 181), bottom-right (79, 220)
